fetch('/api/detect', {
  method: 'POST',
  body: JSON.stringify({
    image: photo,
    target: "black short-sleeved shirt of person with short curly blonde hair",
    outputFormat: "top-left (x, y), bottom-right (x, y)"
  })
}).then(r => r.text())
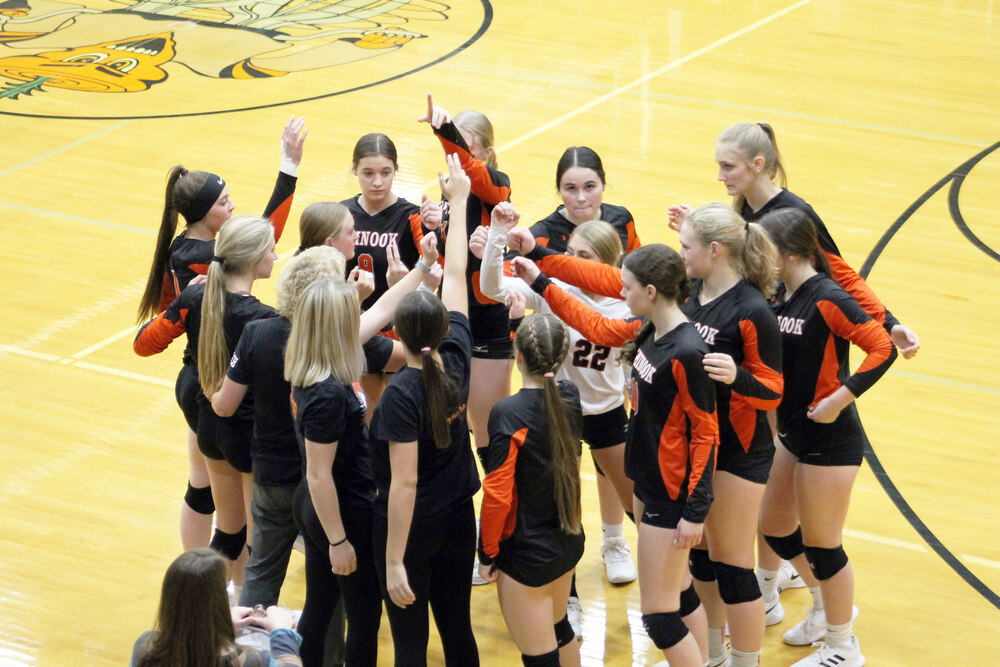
top-left (226, 317), bottom-right (302, 485)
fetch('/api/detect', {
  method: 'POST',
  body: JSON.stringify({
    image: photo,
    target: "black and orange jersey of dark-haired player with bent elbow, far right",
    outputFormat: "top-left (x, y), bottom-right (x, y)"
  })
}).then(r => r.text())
top-left (774, 274), bottom-right (896, 448)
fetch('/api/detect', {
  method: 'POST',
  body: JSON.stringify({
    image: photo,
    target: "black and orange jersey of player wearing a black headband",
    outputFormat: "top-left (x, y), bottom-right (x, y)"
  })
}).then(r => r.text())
top-left (159, 171), bottom-right (298, 313)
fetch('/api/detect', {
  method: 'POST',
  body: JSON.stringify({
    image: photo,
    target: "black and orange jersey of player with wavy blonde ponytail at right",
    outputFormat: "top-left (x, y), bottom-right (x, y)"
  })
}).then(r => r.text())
top-left (681, 280), bottom-right (784, 452)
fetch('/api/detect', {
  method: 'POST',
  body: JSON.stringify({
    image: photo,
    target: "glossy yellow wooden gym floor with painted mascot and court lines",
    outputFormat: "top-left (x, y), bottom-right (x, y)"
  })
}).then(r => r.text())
top-left (0, 0), bottom-right (1000, 666)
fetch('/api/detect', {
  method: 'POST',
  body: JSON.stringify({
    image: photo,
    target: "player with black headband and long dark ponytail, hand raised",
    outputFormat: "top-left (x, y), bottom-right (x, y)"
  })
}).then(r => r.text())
top-left (137, 117), bottom-right (308, 550)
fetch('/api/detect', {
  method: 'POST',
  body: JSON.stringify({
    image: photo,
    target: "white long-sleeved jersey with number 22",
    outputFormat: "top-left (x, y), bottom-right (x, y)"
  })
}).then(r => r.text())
top-left (479, 226), bottom-right (631, 415)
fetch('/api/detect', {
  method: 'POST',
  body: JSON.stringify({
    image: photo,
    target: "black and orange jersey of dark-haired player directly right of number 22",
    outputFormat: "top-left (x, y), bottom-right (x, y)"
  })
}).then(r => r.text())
top-left (625, 322), bottom-right (719, 523)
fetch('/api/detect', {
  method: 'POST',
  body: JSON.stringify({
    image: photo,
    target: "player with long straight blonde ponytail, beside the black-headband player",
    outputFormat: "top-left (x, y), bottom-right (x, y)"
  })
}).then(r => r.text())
top-left (133, 217), bottom-right (278, 597)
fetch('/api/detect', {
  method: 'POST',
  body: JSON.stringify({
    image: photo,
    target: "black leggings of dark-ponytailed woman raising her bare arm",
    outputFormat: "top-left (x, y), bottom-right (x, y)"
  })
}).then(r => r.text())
top-left (374, 499), bottom-right (479, 667)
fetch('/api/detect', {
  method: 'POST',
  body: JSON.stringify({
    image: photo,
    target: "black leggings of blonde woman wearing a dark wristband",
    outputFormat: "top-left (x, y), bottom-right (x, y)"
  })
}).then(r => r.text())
top-left (295, 480), bottom-right (382, 667)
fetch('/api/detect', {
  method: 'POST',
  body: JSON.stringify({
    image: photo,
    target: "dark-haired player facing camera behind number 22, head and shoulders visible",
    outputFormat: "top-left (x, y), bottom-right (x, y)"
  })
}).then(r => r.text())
top-left (530, 146), bottom-right (641, 252)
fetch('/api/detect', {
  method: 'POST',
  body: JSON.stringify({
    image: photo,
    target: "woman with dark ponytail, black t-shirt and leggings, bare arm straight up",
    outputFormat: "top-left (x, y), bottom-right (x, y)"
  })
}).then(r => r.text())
top-left (372, 155), bottom-right (479, 667)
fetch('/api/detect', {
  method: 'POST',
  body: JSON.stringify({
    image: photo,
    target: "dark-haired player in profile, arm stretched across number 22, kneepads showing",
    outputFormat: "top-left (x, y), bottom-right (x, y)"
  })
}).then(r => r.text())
top-left (511, 244), bottom-right (719, 667)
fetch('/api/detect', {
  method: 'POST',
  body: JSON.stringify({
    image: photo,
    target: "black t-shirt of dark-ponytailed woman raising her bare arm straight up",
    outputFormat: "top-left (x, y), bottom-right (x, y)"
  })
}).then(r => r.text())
top-left (372, 312), bottom-right (479, 523)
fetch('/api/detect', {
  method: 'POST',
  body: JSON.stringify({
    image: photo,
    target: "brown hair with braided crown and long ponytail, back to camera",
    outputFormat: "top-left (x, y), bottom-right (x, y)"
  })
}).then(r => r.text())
top-left (514, 314), bottom-right (582, 535)
